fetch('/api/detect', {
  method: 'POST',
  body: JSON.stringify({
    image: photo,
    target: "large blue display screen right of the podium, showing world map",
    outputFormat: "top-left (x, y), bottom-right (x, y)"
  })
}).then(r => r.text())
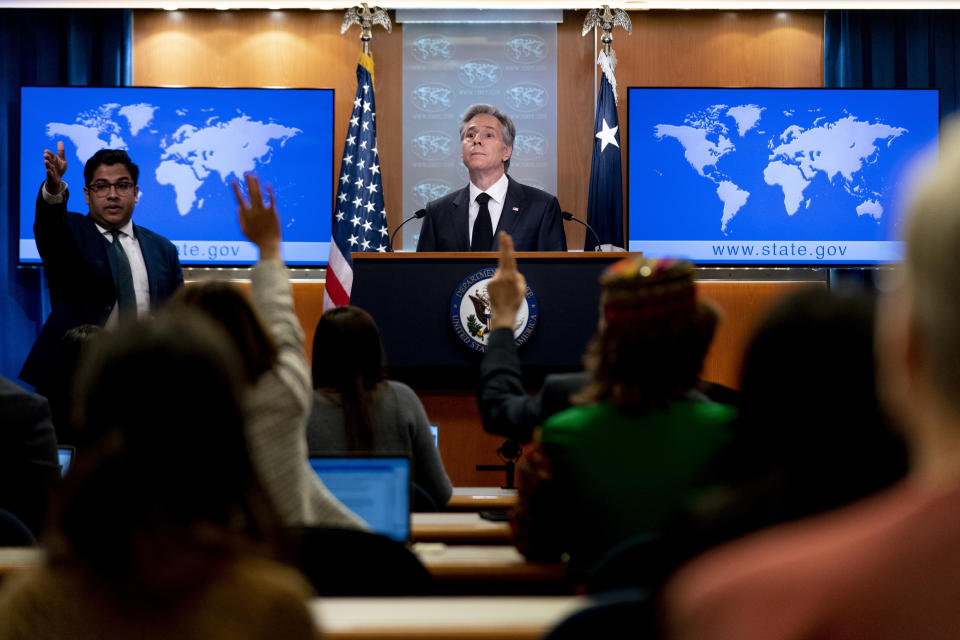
top-left (627, 87), bottom-right (939, 265)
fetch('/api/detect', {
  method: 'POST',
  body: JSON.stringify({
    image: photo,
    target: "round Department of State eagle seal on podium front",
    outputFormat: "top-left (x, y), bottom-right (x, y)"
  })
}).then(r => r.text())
top-left (450, 267), bottom-right (540, 353)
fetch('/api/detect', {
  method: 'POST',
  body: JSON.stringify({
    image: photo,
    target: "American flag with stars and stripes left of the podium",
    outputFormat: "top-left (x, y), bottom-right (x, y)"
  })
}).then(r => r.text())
top-left (323, 53), bottom-right (390, 310)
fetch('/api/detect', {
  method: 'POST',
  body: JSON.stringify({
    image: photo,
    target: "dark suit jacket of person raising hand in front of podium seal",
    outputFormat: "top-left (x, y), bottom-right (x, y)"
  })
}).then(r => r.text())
top-left (477, 329), bottom-right (590, 443)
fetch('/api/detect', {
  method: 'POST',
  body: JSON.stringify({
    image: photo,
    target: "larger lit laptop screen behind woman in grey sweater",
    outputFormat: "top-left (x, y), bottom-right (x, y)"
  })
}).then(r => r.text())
top-left (310, 456), bottom-right (410, 542)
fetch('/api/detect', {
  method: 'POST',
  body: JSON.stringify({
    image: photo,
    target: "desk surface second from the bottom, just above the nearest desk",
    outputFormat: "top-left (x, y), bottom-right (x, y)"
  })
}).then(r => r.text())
top-left (413, 542), bottom-right (566, 582)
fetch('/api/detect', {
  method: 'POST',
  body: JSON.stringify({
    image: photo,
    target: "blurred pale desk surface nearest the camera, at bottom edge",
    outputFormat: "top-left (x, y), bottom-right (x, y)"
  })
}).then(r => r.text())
top-left (310, 596), bottom-right (592, 640)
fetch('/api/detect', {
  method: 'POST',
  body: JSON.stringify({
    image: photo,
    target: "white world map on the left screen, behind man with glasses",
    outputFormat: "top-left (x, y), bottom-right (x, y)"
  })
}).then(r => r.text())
top-left (46, 102), bottom-right (302, 216)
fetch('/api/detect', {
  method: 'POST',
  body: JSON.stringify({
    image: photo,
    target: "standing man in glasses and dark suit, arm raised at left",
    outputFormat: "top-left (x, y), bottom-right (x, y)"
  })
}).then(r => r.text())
top-left (20, 142), bottom-right (183, 393)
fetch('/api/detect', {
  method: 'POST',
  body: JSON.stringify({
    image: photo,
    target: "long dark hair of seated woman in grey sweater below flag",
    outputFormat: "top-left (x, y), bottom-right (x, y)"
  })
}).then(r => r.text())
top-left (313, 305), bottom-right (383, 451)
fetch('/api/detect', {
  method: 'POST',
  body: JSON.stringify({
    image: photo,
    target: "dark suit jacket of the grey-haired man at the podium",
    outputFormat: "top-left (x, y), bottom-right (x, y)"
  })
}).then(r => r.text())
top-left (417, 176), bottom-right (567, 251)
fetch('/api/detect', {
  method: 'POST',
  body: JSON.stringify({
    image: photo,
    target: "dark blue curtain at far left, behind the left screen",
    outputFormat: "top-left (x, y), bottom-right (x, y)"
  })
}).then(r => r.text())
top-left (0, 10), bottom-right (133, 388)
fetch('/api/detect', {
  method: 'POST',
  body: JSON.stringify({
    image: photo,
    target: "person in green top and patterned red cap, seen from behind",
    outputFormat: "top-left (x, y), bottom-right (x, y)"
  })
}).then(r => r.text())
top-left (510, 242), bottom-right (735, 579)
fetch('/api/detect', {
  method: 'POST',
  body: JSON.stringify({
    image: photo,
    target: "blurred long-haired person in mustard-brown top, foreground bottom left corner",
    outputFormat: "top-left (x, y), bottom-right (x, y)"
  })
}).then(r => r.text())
top-left (0, 311), bottom-right (314, 640)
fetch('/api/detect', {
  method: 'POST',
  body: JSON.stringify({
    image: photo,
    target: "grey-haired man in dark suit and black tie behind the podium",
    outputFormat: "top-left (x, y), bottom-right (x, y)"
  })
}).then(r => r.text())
top-left (417, 104), bottom-right (567, 251)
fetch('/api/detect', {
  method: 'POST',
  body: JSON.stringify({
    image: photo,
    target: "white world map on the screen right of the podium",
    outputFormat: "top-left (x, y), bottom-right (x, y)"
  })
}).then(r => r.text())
top-left (652, 104), bottom-right (910, 235)
